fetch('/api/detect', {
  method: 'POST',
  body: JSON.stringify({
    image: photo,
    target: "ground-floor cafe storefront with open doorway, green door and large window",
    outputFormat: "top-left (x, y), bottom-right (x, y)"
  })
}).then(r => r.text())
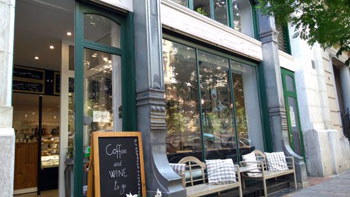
top-left (13, 0), bottom-right (271, 197)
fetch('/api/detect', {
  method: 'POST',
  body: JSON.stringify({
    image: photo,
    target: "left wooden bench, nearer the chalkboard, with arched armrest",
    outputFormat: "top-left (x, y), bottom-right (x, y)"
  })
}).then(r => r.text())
top-left (179, 156), bottom-right (242, 197)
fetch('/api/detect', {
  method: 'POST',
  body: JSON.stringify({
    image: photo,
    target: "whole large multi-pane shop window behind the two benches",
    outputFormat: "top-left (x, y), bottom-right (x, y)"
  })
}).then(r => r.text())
top-left (163, 39), bottom-right (264, 162)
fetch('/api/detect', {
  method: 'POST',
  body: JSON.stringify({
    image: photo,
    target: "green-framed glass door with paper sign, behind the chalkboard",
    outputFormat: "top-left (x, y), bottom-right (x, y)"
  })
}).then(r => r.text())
top-left (74, 3), bottom-right (132, 196)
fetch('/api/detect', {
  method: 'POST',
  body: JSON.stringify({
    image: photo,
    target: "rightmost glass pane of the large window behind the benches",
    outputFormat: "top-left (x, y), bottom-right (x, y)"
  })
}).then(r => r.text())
top-left (231, 60), bottom-right (264, 150)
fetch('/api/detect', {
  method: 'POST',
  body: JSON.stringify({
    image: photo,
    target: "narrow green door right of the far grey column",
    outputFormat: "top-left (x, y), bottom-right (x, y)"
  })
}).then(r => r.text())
top-left (281, 68), bottom-right (305, 159)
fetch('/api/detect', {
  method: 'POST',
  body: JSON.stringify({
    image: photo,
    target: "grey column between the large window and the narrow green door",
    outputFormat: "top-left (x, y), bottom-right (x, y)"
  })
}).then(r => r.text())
top-left (258, 12), bottom-right (307, 186)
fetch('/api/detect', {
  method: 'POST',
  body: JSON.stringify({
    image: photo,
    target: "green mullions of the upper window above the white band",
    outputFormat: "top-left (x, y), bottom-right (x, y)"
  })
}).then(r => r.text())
top-left (174, 0), bottom-right (259, 39)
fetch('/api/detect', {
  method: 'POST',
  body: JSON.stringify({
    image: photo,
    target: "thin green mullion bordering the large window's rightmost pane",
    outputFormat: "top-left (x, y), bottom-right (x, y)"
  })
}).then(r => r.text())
top-left (229, 60), bottom-right (241, 161)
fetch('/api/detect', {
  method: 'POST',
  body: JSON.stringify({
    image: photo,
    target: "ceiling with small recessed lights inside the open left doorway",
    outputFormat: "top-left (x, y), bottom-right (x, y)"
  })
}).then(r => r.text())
top-left (14, 0), bottom-right (74, 71)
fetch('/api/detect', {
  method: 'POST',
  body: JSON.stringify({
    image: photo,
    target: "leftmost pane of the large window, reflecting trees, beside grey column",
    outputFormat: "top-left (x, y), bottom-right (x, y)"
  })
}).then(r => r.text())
top-left (163, 40), bottom-right (201, 157)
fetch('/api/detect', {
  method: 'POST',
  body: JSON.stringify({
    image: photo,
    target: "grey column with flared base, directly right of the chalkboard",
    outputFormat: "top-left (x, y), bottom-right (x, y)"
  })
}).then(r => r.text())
top-left (134, 0), bottom-right (186, 197)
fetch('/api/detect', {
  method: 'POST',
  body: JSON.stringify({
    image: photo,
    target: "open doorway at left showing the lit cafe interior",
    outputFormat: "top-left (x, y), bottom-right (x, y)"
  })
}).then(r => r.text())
top-left (13, 0), bottom-right (75, 196)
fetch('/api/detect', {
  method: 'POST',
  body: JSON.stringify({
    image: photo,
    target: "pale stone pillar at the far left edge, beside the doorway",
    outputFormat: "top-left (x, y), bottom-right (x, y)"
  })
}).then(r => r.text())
top-left (0, 0), bottom-right (15, 197)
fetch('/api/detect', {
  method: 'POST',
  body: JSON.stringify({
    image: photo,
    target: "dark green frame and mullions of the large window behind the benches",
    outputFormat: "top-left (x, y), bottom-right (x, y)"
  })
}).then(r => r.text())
top-left (163, 32), bottom-right (272, 161)
